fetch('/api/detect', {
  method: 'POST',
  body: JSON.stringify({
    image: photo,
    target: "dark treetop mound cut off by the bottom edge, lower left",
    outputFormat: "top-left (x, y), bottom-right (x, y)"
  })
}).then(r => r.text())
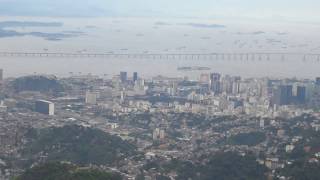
top-left (14, 162), bottom-right (122, 180)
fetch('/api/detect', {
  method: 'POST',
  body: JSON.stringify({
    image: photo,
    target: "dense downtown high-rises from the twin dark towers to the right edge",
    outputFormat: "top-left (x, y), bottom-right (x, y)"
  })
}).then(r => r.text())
top-left (99, 72), bottom-right (320, 117)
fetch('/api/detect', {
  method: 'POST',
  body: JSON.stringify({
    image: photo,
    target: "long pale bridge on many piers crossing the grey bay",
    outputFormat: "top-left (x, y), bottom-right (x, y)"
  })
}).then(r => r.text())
top-left (0, 52), bottom-right (320, 62)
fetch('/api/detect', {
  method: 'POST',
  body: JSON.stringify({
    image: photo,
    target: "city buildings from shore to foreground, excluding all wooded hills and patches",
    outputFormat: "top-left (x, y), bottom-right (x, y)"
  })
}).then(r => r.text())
top-left (0, 71), bottom-right (320, 179)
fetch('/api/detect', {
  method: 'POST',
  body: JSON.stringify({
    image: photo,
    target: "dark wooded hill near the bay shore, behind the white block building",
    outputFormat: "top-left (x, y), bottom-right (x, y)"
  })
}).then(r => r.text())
top-left (12, 76), bottom-right (63, 92)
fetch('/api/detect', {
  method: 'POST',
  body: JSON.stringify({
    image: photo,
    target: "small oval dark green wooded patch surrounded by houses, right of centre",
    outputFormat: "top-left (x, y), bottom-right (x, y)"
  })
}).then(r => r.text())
top-left (227, 132), bottom-right (266, 146)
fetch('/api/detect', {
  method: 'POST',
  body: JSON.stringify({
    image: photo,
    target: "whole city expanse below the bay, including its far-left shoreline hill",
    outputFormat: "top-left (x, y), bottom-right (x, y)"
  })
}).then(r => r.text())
top-left (0, 70), bottom-right (320, 179)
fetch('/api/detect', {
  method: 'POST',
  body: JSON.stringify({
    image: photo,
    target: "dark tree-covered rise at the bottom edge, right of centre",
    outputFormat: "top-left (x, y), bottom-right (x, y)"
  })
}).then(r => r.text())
top-left (171, 152), bottom-right (266, 180)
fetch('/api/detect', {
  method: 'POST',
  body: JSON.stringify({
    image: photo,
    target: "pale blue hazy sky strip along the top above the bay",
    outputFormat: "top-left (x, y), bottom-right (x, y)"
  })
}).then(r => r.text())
top-left (0, 0), bottom-right (320, 22)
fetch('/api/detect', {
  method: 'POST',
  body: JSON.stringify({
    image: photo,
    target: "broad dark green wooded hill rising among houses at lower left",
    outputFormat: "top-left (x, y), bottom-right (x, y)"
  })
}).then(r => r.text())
top-left (22, 125), bottom-right (136, 165)
